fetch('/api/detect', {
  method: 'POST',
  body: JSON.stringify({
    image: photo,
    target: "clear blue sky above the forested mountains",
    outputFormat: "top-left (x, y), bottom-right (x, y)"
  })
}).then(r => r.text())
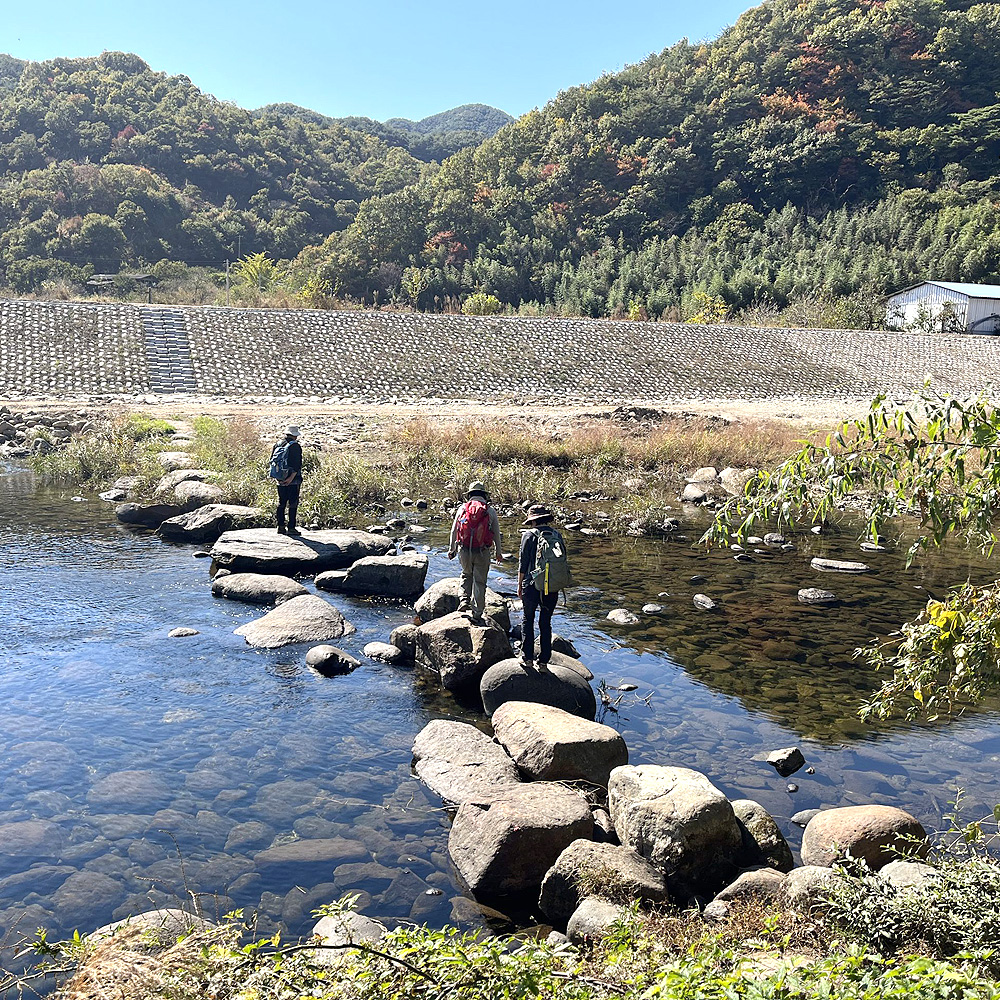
top-left (0, 0), bottom-right (750, 120)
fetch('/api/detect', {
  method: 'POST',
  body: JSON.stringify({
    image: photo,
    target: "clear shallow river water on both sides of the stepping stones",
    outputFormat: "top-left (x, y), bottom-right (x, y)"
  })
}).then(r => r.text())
top-left (0, 469), bottom-right (1000, 960)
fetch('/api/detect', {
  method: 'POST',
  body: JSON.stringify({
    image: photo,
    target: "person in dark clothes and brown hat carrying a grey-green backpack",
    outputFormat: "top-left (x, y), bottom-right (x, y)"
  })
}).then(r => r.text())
top-left (517, 504), bottom-right (573, 670)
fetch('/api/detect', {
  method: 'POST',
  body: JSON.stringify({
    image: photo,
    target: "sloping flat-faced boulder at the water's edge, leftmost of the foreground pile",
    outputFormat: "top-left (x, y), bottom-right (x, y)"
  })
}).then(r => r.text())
top-left (413, 719), bottom-right (521, 805)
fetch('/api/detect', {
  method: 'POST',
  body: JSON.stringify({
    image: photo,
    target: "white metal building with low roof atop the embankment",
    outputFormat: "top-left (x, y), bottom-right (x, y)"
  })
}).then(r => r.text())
top-left (885, 281), bottom-right (1000, 335)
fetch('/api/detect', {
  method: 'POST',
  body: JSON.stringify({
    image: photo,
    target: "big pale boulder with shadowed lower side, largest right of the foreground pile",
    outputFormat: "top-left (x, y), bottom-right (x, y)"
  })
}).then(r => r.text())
top-left (608, 764), bottom-right (743, 892)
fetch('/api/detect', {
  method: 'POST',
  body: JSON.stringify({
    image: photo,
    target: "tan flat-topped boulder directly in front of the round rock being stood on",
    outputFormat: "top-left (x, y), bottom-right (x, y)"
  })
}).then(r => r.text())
top-left (493, 701), bottom-right (628, 788)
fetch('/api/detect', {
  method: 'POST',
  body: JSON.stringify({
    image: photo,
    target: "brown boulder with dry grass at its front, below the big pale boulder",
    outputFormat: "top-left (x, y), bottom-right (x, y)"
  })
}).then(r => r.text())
top-left (538, 840), bottom-right (668, 924)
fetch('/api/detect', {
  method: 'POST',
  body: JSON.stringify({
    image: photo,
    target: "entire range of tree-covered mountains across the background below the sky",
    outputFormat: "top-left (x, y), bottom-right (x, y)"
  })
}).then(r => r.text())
top-left (0, 0), bottom-right (1000, 325)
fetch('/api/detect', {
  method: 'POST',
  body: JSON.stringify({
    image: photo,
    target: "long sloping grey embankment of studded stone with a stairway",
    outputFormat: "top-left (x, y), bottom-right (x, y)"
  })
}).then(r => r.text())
top-left (0, 300), bottom-right (1000, 403)
